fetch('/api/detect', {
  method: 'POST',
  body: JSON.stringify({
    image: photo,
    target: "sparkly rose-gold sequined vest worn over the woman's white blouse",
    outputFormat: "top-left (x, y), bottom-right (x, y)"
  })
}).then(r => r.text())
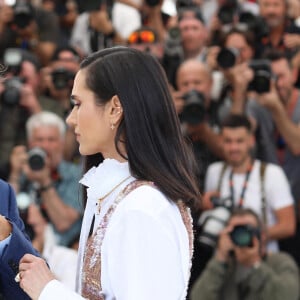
top-left (81, 180), bottom-right (194, 300)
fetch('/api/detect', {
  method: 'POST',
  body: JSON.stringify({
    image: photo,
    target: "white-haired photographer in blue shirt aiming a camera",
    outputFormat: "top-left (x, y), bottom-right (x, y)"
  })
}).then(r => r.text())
top-left (9, 111), bottom-right (83, 246)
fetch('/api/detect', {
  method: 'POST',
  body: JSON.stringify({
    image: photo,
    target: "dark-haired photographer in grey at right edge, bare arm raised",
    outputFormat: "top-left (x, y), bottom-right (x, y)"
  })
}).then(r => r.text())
top-left (249, 50), bottom-right (300, 263)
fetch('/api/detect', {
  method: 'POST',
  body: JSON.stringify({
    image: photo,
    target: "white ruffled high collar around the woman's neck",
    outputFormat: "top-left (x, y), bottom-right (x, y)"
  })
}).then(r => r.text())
top-left (79, 158), bottom-right (130, 198)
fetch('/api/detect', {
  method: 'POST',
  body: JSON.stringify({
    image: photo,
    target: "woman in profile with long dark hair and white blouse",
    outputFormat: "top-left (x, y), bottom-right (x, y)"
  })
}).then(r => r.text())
top-left (19, 47), bottom-right (200, 300)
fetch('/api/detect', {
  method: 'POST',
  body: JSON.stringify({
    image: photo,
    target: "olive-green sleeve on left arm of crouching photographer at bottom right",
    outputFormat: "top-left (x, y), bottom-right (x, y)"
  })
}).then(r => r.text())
top-left (191, 258), bottom-right (227, 300)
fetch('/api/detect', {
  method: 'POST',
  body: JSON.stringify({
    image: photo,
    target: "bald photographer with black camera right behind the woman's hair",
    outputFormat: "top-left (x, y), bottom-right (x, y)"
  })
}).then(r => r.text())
top-left (174, 59), bottom-right (222, 186)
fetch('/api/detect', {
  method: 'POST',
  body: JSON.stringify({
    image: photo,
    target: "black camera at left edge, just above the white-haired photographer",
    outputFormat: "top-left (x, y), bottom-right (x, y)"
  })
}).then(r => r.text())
top-left (1, 77), bottom-right (25, 106)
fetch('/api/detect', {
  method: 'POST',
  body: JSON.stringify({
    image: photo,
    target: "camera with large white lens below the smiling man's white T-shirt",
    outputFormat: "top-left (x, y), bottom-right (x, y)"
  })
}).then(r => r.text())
top-left (198, 197), bottom-right (233, 248)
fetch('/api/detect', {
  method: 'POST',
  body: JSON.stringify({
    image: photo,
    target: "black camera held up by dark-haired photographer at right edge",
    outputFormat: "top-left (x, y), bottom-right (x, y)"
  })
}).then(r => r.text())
top-left (248, 59), bottom-right (272, 94)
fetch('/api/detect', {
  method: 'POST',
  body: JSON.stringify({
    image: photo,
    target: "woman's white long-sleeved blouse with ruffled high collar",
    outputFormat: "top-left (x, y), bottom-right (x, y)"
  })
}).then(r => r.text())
top-left (39, 159), bottom-right (190, 300)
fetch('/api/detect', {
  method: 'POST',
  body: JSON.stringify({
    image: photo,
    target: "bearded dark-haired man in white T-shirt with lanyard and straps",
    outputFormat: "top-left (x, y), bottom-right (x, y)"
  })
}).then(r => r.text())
top-left (204, 115), bottom-right (295, 252)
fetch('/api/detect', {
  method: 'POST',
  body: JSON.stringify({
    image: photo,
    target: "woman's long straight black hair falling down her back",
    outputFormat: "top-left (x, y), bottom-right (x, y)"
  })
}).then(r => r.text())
top-left (80, 47), bottom-right (200, 207)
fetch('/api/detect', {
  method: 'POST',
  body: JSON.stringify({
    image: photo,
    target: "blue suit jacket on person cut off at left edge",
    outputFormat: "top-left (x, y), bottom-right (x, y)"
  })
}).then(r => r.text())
top-left (0, 179), bottom-right (38, 300)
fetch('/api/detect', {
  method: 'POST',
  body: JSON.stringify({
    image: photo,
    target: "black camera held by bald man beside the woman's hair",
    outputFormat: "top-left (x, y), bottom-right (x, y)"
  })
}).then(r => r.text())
top-left (179, 90), bottom-right (206, 125)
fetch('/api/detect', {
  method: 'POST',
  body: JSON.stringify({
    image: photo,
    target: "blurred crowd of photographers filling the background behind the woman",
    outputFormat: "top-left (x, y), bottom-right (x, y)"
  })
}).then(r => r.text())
top-left (0, 0), bottom-right (300, 299)
